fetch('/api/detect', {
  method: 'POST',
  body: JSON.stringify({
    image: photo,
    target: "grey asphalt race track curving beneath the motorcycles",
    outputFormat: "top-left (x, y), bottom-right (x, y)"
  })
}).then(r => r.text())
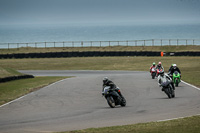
top-left (0, 71), bottom-right (200, 133)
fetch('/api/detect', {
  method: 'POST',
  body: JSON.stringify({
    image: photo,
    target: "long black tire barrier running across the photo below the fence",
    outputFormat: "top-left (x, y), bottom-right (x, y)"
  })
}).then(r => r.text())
top-left (0, 51), bottom-right (200, 59)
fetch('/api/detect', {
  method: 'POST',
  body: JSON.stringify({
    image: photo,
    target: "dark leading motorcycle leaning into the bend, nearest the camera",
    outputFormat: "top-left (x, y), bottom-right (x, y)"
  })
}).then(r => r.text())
top-left (102, 86), bottom-right (126, 108)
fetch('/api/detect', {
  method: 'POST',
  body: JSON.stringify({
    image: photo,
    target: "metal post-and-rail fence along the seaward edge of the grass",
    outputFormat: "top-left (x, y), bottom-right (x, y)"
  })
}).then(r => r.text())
top-left (0, 39), bottom-right (200, 49)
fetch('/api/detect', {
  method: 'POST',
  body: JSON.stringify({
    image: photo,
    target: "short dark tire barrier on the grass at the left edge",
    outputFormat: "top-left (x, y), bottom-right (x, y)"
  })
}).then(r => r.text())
top-left (0, 75), bottom-right (34, 83)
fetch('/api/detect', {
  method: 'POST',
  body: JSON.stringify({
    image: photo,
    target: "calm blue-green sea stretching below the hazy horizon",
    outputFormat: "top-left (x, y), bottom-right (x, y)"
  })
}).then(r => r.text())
top-left (0, 24), bottom-right (200, 47)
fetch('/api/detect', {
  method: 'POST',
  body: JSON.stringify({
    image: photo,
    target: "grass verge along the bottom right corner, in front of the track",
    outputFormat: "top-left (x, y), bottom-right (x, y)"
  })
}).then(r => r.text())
top-left (59, 116), bottom-right (200, 133)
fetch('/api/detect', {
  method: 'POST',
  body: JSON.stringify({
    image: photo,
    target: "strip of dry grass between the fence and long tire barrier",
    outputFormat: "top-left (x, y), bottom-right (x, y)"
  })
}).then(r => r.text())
top-left (0, 45), bottom-right (200, 54)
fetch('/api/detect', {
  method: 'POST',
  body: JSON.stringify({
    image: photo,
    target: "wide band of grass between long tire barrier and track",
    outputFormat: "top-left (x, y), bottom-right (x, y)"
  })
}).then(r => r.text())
top-left (0, 57), bottom-right (200, 87)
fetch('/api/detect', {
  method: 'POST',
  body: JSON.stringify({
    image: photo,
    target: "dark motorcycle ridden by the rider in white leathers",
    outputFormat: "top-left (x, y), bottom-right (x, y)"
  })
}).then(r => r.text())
top-left (161, 80), bottom-right (175, 98)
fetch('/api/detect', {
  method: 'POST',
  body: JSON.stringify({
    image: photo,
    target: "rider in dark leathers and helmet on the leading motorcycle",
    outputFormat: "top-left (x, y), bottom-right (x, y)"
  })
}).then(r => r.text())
top-left (102, 77), bottom-right (124, 98)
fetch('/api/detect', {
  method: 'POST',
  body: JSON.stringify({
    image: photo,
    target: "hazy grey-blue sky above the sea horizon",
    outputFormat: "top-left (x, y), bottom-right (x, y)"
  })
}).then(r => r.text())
top-left (0, 0), bottom-right (200, 24)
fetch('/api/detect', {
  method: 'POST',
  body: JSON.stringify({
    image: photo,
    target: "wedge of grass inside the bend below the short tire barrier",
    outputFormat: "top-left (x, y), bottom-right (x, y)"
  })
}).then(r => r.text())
top-left (0, 77), bottom-right (66, 105)
